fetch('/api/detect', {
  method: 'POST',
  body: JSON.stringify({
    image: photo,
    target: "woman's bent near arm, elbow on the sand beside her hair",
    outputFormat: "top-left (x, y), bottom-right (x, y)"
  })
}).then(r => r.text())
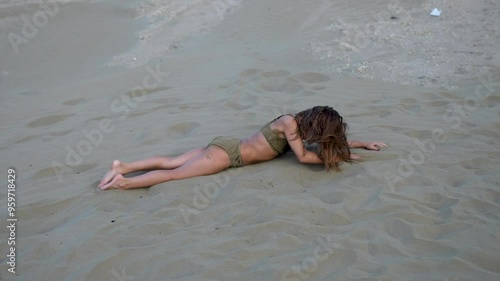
top-left (282, 116), bottom-right (323, 164)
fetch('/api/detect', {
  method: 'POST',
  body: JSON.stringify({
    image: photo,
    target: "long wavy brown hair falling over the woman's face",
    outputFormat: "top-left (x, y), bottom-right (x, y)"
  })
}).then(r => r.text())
top-left (295, 106), bottom-right (351, 171)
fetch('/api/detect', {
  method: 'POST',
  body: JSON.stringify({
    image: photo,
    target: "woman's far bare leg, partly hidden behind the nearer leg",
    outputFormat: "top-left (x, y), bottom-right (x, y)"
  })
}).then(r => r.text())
top-left (99, 148), bottom-right (205, 187)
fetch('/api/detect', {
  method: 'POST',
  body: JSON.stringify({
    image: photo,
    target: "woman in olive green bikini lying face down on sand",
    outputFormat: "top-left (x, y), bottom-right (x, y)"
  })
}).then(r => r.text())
top-left (99, 106), bottom-right (387, 190)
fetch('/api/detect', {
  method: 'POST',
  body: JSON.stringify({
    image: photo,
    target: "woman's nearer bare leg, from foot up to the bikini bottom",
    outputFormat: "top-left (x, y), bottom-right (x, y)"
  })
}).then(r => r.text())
top-left (101, 146), bottom-right (230, 189)
